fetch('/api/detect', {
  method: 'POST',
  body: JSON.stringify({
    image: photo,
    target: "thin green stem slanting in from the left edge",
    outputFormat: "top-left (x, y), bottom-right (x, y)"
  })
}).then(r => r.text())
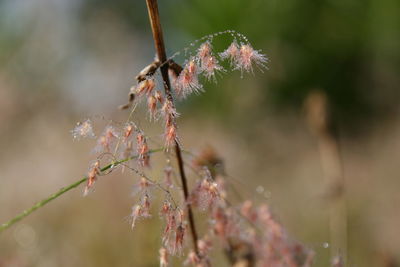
top-left (0, 148), bottom-right (164, 233)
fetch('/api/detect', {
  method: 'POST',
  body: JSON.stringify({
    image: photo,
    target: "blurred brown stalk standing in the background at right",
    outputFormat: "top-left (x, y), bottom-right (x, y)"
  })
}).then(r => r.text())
top-left (305, 91), bottom-right (347, 263)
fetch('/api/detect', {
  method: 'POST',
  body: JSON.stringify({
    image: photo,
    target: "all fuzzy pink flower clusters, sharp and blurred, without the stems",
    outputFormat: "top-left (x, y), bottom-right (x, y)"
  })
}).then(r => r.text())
top-left (72, 32), bottom-right (328, 267)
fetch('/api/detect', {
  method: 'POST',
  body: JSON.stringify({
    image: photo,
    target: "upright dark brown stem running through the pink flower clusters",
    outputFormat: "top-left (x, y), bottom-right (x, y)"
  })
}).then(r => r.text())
top-left (146, 0), bottom-right (198, 254)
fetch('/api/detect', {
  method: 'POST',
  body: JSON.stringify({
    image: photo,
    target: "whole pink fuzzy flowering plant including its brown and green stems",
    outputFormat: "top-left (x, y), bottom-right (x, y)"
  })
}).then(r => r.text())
top-left (0, 0), bottom-right (328, 267)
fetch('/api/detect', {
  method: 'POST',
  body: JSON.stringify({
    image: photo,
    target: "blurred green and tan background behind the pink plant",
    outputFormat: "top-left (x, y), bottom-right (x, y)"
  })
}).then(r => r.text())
top-left (0, 0), bottom-right (400, 267)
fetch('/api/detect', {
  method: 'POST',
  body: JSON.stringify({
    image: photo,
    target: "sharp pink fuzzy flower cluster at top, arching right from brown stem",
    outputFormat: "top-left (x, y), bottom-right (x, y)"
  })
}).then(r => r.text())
top-left (119, 35), bottom-right (267, 152)
